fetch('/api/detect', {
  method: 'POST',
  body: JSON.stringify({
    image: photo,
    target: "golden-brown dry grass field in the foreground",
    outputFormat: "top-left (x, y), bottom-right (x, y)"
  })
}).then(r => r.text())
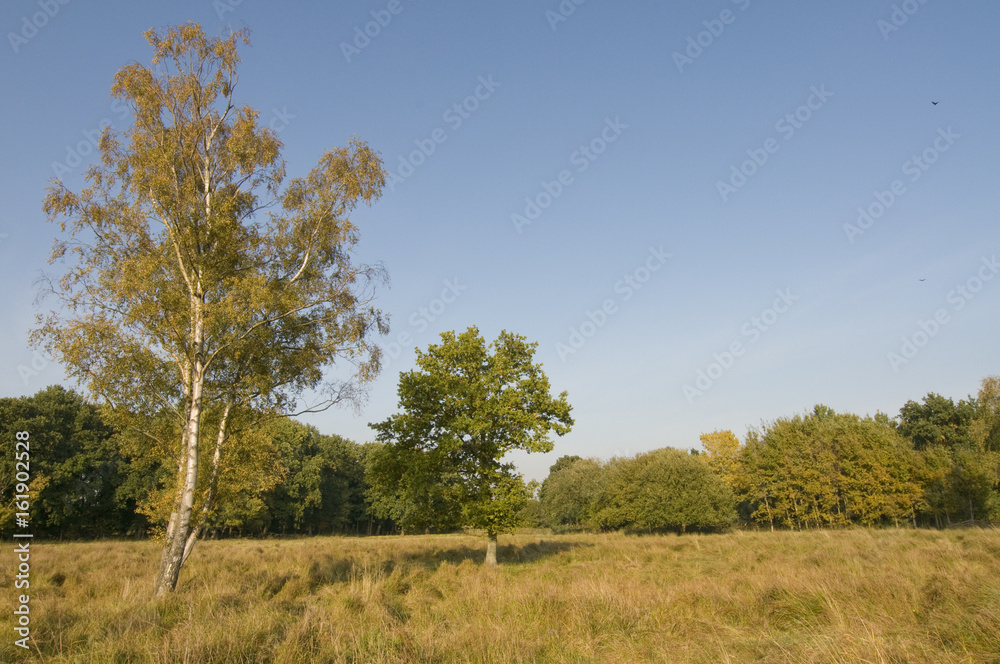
top-left (0, 530), bottom-right (1000, 664)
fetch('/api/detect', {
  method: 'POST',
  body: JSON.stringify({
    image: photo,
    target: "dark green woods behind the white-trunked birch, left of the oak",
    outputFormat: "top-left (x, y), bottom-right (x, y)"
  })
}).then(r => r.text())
top-left (0, 385), bottom-right (395, 539)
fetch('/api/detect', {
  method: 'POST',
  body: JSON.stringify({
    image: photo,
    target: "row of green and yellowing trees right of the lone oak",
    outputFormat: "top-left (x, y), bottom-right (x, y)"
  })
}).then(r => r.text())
top-left (526, 376), bottom-right (1000, 532)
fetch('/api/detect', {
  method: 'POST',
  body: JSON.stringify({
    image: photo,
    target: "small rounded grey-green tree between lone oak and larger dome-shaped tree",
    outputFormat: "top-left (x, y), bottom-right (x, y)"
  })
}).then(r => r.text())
top-left (539, 457), bottom-right (605, 528)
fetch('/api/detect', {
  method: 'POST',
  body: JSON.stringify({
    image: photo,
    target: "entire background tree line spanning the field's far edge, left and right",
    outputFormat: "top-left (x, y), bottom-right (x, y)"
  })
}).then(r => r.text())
top-left (0, 374), bottom-right (1000, 539)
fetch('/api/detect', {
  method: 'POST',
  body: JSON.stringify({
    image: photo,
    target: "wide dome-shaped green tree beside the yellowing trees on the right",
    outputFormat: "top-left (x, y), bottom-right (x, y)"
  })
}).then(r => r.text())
top-left (590, 448), bottom-right (736, 533)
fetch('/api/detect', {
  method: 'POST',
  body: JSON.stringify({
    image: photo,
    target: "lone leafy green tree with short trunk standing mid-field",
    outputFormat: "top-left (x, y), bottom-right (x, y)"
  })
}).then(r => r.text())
top-left (367, 327), bottom-right (573, 565)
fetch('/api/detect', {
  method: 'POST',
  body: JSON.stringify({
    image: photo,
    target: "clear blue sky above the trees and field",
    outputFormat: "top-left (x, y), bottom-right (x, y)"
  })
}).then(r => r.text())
top-left (0, 0), bottom-right (1000, 479)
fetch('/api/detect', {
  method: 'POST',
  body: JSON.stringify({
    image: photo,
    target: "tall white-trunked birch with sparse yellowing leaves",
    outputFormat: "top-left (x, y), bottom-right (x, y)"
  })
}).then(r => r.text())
top-left (34, 23), bottom-right (388, 596)
